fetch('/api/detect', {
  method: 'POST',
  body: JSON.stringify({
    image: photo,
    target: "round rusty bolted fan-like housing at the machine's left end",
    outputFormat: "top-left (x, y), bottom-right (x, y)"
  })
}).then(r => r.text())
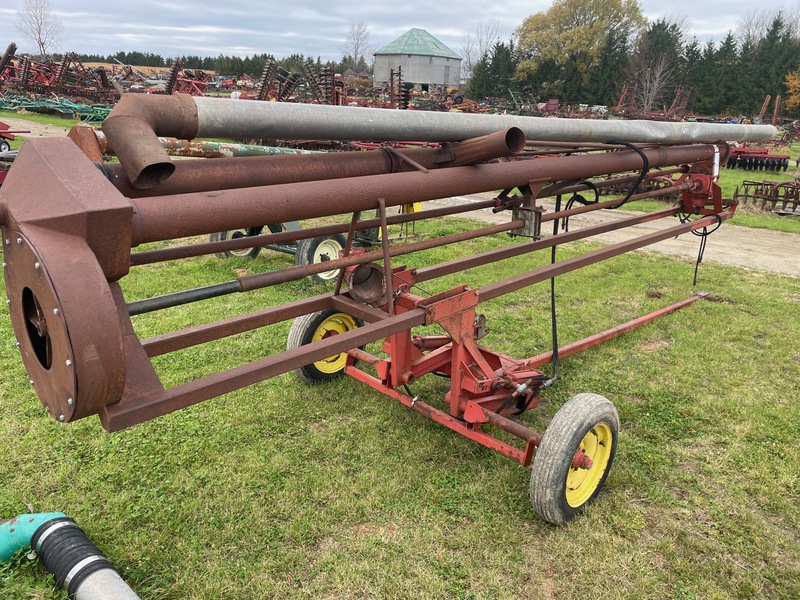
top-left (3, 227), bottom-right (125, 422)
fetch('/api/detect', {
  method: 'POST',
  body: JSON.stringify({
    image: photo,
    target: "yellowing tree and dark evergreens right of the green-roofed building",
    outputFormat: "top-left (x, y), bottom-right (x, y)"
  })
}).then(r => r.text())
top-left (469, 0), bottom-right (800, 116)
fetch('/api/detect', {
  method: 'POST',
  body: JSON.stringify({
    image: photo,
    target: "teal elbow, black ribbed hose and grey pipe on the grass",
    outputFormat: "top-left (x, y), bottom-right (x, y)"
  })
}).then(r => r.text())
top-left (0, 512), bottom-right (139, 600)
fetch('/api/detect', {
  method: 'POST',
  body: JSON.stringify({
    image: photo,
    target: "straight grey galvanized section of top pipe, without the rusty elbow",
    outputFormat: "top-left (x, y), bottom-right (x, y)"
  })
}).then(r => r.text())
top-left (194, 97), bottom-right (777, 144)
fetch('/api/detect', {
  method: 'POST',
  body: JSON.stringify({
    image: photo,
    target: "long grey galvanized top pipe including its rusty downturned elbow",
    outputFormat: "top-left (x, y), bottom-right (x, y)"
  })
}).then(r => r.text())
top-left (103, 94), bottom-right (777, 188)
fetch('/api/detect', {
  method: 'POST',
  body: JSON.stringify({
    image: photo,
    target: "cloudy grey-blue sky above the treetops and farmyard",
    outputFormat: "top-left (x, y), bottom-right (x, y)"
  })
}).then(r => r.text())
top-left (0, 0), bottom-right (800, 61)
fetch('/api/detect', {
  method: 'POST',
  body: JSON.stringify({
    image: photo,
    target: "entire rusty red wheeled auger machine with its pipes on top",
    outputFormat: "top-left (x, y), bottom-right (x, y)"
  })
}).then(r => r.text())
top-left (0, 95), bottom-right (775, 523)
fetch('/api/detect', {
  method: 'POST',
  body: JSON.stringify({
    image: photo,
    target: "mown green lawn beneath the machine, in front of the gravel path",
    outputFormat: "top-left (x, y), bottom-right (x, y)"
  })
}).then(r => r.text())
top-left (0, 220), bottom-right (800, 600)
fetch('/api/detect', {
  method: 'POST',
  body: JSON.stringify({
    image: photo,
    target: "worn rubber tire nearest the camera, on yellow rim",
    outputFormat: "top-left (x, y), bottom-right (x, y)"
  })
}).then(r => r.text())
top-left (530, 393), bottom-right (619, 525)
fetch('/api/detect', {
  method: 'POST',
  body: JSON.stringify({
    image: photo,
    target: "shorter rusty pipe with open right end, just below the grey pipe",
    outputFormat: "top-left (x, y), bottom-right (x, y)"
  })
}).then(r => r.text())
top-left (101, 127), bottom-right (525, 198)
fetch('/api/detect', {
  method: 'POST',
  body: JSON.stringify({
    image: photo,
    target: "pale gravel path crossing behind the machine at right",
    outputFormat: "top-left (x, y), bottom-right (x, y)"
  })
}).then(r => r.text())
top-left (426, 194), bottom-right (800, 277)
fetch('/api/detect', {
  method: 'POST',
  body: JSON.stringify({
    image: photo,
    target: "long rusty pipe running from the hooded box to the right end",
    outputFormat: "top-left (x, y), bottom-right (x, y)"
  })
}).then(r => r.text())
top-left (131, 144), bottom-right (715, 246)
